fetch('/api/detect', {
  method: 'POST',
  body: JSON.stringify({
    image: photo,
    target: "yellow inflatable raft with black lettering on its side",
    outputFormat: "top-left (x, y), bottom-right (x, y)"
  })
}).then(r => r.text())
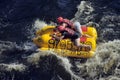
top-left (33, 26), bottom-right (97, 58)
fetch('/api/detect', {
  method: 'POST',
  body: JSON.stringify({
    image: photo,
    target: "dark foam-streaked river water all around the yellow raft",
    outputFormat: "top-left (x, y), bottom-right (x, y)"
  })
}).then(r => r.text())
top-left (0, 0), bottom-right (120, 80)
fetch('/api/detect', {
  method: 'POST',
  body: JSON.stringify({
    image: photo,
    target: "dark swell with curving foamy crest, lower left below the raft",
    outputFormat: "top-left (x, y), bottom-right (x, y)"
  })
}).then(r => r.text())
top-left (0, 42), bottom-right (80, 80)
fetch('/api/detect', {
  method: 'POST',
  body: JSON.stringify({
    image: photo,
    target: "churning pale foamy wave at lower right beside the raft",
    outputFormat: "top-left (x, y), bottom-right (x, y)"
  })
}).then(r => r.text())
top-left (76, 40), bottom-right (120, 80)
